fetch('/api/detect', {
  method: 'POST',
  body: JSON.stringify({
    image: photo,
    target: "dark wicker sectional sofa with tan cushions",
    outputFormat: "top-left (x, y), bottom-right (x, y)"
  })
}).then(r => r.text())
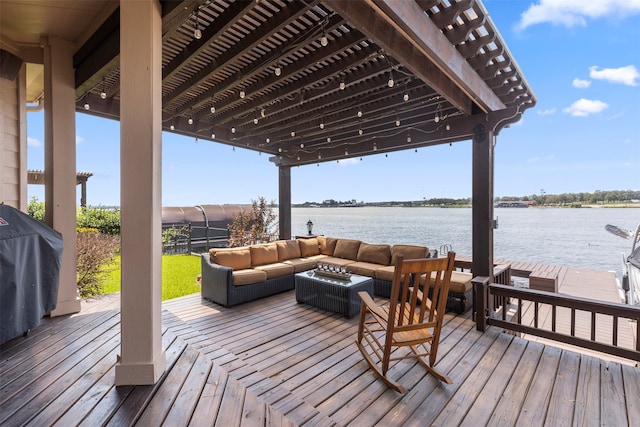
top-left (201, 236), bottom-right (472, 313)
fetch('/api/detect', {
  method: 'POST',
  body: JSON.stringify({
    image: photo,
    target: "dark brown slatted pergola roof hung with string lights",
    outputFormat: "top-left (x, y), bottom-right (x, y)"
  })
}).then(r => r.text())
top-left (74, 0), bottom-right (536, 166)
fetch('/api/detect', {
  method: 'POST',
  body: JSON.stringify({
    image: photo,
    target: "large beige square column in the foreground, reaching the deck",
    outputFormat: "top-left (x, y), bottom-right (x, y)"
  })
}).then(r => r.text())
top-left (115, 0), bottom-right (166, 385)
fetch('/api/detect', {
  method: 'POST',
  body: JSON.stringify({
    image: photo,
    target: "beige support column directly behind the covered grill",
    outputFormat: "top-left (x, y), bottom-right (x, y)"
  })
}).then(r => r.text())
top-left (41, 37), bottom-right (80, 316)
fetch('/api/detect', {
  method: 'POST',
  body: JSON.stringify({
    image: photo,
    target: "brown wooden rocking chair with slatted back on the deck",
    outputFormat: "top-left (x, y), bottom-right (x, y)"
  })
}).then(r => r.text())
top-left (356, 252), bottom-right (455, 393)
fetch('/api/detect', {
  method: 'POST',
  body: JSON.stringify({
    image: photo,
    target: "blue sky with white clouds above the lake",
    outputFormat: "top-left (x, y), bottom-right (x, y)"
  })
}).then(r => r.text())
top-left (27, 0), bottom-right (640, 206)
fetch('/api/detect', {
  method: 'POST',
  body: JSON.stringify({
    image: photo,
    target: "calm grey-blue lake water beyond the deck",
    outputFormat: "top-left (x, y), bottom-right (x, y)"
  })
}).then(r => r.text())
top-left (291, 207), bottom-right (640, 278)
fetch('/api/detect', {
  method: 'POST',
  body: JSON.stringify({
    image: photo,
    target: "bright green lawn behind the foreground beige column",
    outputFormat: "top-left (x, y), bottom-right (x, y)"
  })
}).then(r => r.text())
top-left (102, 255), bottom-right (201, 301)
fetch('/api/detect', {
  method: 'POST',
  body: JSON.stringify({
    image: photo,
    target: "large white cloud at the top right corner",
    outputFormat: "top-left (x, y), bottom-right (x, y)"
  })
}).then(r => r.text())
top-left (517, 0), bottom-right (640, 30)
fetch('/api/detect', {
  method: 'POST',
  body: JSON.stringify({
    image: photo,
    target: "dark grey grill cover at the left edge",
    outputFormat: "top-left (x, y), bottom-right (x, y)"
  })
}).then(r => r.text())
top-left (0, 205), bottom-right (63, 344)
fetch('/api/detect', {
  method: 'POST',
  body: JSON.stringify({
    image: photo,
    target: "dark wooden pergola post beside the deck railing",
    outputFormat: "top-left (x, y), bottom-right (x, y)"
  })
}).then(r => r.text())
top-left (471, 124), bottom-right (495, 311)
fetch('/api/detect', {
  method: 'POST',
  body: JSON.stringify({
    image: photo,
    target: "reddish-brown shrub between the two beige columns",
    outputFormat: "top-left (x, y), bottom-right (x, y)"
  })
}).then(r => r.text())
top-left (76, 228), bottom-right (120, 298)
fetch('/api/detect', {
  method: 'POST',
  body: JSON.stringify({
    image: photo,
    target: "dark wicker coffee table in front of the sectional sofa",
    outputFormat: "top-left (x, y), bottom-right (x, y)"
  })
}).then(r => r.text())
top-left (294, 270), bottom-right (373, 317)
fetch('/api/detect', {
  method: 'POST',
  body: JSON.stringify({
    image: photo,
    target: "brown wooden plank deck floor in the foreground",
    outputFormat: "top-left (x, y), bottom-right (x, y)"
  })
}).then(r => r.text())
top-left (0, 276), bottom-right (640, 426)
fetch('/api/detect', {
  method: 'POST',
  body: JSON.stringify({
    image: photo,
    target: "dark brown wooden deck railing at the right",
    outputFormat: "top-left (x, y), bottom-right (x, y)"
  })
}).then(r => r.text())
top-left (473, 277), bottom-right (640, 362)
